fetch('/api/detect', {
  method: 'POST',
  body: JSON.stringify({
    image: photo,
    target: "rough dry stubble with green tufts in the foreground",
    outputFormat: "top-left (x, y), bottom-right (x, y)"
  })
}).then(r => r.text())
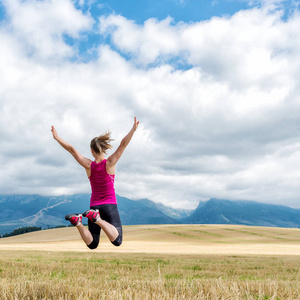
top-left (0, 251), bottom-right (300, 300)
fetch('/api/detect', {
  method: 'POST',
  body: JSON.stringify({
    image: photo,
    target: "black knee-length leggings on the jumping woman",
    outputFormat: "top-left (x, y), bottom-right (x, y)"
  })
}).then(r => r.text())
top-left (88, 204), bottom-right (123, 249)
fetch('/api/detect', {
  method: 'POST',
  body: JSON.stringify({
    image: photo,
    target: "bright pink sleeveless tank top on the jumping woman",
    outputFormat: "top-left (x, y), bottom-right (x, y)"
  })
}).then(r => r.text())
top-left (89, 159), bottom-right (117, 206)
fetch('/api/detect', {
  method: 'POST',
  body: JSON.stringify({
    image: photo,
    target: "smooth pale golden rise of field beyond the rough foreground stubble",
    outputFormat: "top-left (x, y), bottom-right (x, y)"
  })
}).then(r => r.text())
top-left (0, 225), bottom-right (300, 255)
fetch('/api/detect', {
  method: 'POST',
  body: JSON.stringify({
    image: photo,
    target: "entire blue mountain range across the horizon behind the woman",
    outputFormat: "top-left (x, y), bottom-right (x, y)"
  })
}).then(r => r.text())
top-left (0, 194), bottom-right (300, 235)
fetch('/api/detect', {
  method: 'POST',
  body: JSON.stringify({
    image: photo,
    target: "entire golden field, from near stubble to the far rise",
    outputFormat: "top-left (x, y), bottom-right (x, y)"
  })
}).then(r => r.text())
top-left (0, 225), bottom-right (300, 300)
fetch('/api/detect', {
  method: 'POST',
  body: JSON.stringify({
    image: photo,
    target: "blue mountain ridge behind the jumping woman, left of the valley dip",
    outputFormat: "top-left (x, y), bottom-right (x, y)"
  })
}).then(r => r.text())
top-left (0, 194), bottom-right (185, 235)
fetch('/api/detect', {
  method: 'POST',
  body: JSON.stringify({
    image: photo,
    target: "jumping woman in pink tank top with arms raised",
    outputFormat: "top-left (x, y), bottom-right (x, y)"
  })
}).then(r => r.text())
top-left (51, 118), bottom-right (139, 249)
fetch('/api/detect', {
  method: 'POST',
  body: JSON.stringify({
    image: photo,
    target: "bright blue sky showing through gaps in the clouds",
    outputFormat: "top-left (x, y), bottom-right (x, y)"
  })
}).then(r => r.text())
top-left (0, 0), bottom-right (298, 61)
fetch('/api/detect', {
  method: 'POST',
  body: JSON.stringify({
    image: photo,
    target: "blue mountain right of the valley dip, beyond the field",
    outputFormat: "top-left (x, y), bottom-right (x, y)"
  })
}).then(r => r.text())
top-left (181, 199), bottom-right (300, 228)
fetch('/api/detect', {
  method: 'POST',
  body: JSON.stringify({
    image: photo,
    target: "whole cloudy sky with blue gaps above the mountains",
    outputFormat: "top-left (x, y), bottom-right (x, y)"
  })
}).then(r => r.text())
top-left (0, 0), bottom-right (300, 209)
